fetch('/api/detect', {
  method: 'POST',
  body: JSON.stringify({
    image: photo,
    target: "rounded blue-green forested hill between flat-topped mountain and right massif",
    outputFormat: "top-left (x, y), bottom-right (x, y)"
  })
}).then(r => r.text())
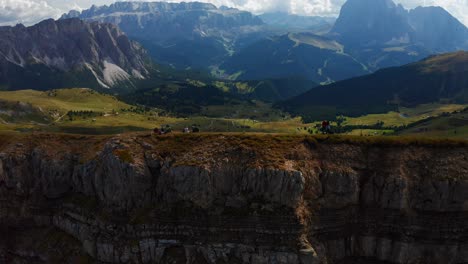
top-left (221, 33), bottom-right (368, 83)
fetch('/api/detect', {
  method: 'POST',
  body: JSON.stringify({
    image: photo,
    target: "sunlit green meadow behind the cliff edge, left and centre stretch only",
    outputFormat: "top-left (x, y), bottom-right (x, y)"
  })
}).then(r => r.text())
top-left (0, 88), bottom-right (307, 134)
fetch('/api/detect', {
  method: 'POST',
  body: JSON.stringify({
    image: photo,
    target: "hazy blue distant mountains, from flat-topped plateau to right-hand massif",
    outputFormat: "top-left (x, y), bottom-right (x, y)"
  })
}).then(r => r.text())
top-left (62, 0), bottom-right (468, 83)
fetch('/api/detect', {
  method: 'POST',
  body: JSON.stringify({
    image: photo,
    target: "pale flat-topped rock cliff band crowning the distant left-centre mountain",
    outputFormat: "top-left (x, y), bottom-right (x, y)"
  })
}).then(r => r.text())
top-left (62, 2), bottom-right (263, 42)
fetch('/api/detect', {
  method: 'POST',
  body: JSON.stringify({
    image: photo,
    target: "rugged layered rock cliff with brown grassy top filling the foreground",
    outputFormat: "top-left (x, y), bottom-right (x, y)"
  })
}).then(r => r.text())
top-left (0, 134), bottom-right (468, 264)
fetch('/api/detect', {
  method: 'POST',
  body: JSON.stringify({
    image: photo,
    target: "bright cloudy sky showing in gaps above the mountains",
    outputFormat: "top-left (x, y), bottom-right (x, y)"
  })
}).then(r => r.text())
top-left (0, 0), bottom-right (468, 26)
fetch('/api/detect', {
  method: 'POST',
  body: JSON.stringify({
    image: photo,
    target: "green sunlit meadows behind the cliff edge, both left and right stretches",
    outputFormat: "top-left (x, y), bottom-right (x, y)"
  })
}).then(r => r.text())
top-left (0, 88), bottom-right (468, 138)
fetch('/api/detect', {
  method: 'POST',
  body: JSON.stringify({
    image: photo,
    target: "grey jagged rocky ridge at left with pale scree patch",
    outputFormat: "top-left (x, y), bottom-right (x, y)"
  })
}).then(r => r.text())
top-left (0, 18), bottom-right (148, 89)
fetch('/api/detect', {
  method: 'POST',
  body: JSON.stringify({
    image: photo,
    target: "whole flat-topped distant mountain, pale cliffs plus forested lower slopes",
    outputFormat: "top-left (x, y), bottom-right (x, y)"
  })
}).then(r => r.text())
top-left (62, 2), bottom-right (264, 69)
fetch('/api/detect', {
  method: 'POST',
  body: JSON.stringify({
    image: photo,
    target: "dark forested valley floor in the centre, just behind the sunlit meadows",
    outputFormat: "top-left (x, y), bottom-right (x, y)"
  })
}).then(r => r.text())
top-left (121, 75), bottom-right (316, 115)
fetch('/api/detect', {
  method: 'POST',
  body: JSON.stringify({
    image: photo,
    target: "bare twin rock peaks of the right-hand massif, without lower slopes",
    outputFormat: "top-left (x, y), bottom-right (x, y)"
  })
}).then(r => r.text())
top-left (331, 0), bottom-right (468, 52)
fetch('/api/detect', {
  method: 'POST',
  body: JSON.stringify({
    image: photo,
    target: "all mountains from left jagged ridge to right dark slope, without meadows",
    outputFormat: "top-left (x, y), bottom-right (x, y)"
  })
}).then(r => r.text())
top-left (0, 0), bottom-right (468, 119)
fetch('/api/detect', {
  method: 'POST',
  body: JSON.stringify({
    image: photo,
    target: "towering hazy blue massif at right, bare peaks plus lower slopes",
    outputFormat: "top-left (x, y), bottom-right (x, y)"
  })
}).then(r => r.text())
top-left (331, 0), bottom-right (468, 71)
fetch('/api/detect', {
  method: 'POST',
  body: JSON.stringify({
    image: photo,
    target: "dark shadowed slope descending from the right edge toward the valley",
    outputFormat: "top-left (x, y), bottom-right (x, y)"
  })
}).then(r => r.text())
top-left (279, 52), bottom-right (468, 120)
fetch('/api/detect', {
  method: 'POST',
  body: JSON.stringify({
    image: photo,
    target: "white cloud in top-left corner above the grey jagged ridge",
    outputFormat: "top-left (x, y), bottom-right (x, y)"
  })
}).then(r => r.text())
top-left (0, 0), bottom-right (60, 25)
